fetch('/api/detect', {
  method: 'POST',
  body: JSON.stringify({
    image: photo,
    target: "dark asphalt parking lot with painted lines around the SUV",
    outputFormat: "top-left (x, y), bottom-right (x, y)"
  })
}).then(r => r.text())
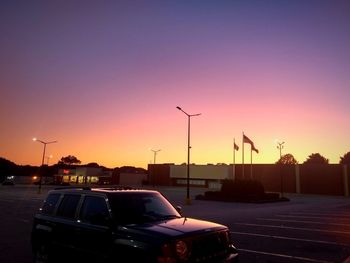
top-left (0, 185), bottom-right (350, 263)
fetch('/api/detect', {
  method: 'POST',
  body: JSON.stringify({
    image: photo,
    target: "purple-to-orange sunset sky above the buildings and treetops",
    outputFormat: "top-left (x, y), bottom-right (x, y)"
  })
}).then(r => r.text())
top-left (0, 0), bottom-right (350, 168)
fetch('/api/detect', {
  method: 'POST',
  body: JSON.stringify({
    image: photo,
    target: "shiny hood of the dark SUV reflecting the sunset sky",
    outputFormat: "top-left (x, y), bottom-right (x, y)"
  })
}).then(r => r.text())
top-left (129, 217), bottom-right (226, 236)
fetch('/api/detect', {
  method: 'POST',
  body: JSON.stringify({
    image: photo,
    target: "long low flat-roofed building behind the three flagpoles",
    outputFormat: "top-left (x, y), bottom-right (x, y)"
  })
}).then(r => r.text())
top-left (148, 164), bottom-right (350, 196)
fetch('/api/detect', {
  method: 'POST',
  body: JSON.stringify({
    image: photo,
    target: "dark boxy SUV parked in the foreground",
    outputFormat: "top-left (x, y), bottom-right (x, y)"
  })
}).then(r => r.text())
top-left (31, 188), bottom-right (238, 263)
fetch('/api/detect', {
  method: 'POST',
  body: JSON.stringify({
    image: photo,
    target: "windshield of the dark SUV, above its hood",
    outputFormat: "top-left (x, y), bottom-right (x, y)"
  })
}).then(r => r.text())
top-left (109, 192), bottom-right (181, 224)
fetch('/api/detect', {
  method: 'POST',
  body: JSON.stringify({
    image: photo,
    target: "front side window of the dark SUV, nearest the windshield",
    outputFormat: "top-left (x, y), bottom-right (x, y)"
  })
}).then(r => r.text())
top-left (80, 196), bottom-right (109, 225)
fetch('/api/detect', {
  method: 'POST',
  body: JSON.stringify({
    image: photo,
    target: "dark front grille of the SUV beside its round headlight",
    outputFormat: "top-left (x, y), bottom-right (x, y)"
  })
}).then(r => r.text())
top-left (190, 231), bottom-right (229, 263)
